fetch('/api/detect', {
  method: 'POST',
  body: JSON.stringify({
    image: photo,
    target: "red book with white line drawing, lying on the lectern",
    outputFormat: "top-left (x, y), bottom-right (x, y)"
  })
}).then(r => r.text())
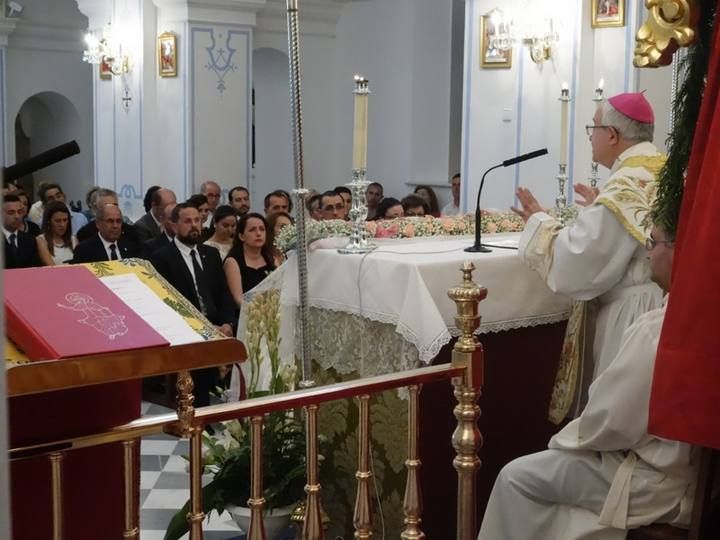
top-left (4, 266), bottom-right (169, 360)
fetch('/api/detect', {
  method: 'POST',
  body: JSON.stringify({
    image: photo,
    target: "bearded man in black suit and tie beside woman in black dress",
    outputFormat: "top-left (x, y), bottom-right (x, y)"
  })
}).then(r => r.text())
top-left (150, 203), bottom-right (236, 407)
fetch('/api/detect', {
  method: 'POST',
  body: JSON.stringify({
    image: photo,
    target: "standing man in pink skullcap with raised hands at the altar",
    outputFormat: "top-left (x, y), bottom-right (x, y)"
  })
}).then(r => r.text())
top-left (513, 93), bottom-right (665, 422)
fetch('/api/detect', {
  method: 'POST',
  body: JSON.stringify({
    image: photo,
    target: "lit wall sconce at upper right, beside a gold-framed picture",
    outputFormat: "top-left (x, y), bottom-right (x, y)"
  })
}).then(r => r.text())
top-left (489, 7), bottom-right (559, 64)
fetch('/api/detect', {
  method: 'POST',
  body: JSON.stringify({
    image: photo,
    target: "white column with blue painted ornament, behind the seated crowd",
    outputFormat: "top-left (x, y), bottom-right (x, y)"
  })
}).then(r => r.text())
top-left (154, 0), bottom-right (265, 202)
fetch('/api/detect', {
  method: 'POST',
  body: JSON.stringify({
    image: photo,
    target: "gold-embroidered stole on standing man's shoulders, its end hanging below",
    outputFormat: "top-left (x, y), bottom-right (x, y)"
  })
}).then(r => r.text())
top-left (545, 150), bottom-right (667, 424)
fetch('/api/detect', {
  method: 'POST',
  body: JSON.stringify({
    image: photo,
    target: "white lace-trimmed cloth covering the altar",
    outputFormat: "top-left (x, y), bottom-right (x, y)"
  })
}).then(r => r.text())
top-left (278, 233), bottom-right (570, 364)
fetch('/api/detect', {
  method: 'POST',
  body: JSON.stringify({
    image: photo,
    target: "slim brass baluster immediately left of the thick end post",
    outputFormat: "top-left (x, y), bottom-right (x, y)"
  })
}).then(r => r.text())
top-left (400, 385), bottom-right (425, 540)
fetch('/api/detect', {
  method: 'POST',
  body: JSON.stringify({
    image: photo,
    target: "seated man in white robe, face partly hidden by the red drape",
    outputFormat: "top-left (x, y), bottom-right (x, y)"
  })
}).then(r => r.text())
top-left (478, 223), bottom-right (698, 540)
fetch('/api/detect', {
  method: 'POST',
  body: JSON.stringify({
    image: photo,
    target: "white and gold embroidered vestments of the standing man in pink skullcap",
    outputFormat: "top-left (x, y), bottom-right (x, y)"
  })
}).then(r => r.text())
top-left (519, 142), bottom-right (665, 423)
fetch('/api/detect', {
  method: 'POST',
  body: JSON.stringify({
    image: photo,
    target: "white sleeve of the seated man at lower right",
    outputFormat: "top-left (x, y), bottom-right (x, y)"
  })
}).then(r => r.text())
top-left (548, 314), bottom-right (662, 451)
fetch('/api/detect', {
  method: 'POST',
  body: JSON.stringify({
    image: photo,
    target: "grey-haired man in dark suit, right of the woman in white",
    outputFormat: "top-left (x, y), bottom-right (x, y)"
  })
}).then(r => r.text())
top-left (73, 204), bottom-right (145, 263)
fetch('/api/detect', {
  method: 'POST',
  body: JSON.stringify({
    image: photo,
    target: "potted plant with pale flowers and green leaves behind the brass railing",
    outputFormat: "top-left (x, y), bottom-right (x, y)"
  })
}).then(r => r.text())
top-left (165, 290), bottom-right (322, 540)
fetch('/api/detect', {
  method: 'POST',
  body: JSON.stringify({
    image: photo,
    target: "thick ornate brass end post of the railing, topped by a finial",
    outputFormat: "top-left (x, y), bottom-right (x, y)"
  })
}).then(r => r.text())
top-left (448, 262), bottom-right (487, 540)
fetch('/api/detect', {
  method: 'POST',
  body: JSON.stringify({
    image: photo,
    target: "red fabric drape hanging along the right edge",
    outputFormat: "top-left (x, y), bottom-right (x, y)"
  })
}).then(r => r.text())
top-left (649, 12), bottom-right (720, 448)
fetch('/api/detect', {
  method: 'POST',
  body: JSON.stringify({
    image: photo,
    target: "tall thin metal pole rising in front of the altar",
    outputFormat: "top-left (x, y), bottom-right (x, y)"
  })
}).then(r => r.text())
top-left (287, 0), bottom-right (315, 388)
